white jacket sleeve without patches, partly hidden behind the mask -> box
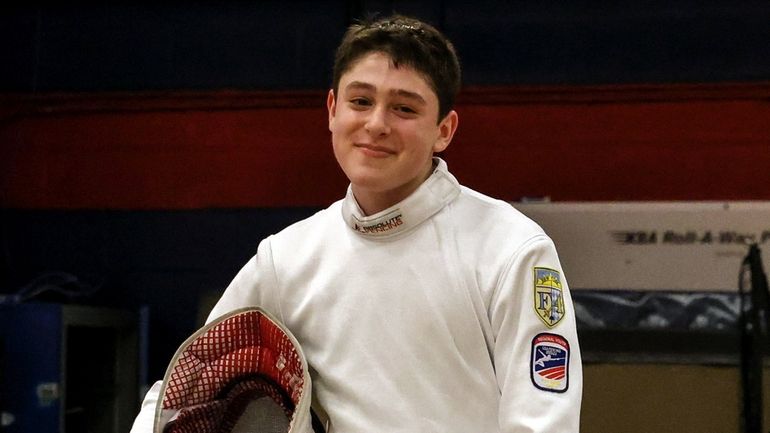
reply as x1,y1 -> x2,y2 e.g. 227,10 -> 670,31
130,238 -> 283,433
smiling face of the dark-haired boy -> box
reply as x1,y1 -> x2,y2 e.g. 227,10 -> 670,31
327,52 -> 457,215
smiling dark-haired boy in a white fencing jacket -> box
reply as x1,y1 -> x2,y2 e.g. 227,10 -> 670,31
135,16 -> 582,433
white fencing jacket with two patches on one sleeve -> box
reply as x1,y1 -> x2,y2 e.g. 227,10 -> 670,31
133,159 -> 582,433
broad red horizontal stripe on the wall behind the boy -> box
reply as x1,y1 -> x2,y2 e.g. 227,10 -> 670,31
0,83 -> 770,209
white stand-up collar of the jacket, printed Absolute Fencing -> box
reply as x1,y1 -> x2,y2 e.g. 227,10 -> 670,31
342,158 -> 460,239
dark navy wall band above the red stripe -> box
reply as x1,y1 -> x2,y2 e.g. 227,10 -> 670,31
0,0 -> 770,92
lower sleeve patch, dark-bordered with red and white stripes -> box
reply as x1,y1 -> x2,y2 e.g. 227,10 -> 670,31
530,333 -> 569,392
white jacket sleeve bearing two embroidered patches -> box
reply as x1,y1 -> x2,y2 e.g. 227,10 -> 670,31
489,235 -> 583,433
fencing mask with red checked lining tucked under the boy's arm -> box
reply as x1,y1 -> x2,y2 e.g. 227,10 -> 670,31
153,308 -> 313,433
